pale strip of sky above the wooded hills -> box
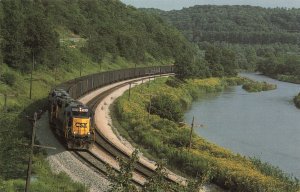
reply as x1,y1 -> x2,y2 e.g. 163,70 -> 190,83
121,0 -> 300,11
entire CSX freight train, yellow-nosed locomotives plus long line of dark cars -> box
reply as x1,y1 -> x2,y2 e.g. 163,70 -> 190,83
48,65 -> 174,149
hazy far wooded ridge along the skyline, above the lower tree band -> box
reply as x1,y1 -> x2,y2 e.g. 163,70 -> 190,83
155,5 -> 300,44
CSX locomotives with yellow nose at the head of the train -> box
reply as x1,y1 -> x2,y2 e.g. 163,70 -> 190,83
48,89 -> 95,149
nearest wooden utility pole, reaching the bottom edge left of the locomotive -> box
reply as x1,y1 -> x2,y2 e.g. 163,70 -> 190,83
25,112 -> 56,192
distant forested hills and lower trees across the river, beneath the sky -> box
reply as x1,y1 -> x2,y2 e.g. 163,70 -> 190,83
143,5 -> 300,80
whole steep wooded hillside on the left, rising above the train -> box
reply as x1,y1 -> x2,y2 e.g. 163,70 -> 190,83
0,0 -> 195,72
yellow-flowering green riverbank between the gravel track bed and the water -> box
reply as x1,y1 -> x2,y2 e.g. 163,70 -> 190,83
116,78 -> 299,191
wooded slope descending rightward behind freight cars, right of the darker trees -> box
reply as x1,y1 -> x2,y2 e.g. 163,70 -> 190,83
44,0 -> 192,63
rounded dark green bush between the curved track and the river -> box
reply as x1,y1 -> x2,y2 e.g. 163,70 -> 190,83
148,94 -> 183,122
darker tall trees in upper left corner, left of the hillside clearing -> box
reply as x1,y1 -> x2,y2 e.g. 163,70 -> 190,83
1,0 -> 59,71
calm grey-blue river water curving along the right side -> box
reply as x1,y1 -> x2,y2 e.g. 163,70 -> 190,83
185,73 -> 300,178
